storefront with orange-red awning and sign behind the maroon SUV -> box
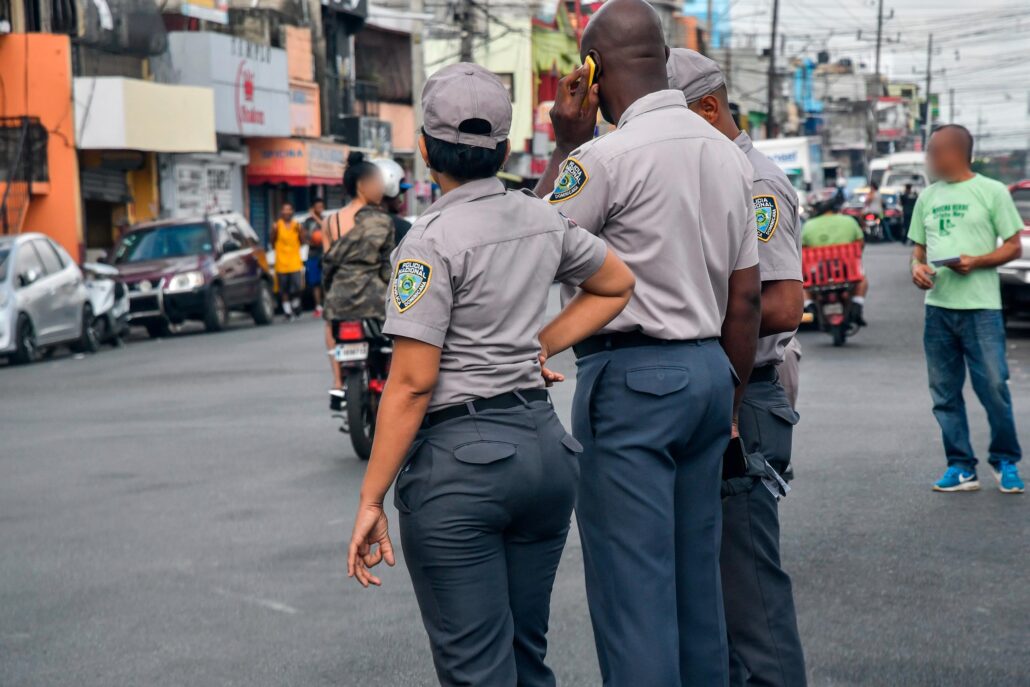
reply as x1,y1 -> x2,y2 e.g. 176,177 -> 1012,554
247,138 -> 348,246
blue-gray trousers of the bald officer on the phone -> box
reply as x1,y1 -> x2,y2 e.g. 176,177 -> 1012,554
573,341 -> 733,687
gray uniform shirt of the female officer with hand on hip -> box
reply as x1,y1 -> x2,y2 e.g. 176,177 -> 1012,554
383,178 -> 608,410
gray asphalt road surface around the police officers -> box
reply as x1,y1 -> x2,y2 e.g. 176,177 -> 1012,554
0,247 -> 1030,687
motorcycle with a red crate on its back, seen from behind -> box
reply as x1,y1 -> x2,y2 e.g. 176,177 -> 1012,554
801,242 -> 863,346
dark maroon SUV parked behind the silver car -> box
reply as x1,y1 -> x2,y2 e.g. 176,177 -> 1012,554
108,212 -> 275,337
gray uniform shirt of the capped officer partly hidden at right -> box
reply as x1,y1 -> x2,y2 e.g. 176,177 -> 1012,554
733,131 -> 802,368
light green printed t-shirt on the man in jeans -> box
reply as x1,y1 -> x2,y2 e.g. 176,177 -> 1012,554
908,174 -> 1023,310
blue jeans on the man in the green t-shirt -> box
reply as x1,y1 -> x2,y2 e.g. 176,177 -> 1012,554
923,305 -> 1022,470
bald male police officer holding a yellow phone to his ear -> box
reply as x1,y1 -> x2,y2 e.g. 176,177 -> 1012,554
538,0 -> 760,687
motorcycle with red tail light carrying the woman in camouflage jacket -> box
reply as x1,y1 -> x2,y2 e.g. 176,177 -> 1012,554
331,319 -> 393,460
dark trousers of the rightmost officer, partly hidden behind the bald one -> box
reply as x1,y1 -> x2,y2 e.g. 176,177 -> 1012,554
721,381 -> 805,687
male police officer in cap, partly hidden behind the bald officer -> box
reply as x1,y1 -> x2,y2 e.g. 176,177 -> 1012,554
668,48 -> 804,687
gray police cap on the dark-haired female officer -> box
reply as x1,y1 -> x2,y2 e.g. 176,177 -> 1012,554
422,62 -> 512,150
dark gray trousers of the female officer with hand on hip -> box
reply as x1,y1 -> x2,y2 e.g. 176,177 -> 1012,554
394,402 -> 582,687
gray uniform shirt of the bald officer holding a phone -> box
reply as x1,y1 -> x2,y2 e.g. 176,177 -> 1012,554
550,90 -> 758,340
